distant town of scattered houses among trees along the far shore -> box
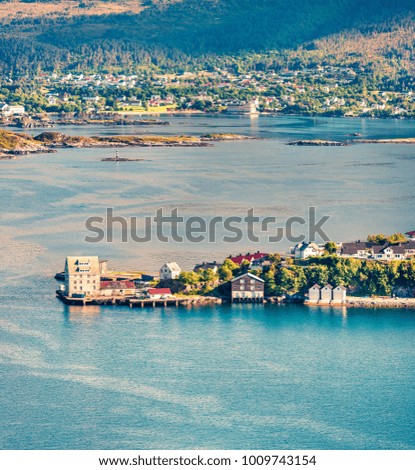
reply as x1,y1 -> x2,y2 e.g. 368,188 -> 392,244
0,65 -> 415,127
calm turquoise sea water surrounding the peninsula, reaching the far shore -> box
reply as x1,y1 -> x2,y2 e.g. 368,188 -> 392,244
0,116 -> 415,449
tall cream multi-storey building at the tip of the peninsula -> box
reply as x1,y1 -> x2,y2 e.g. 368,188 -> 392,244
65,256 -> 101,297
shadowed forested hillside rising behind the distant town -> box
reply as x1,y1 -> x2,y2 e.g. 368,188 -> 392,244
0,0 -> 415,72
